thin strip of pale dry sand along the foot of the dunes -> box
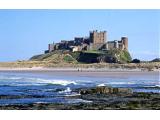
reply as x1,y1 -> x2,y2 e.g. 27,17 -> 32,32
0,67 -> 160,72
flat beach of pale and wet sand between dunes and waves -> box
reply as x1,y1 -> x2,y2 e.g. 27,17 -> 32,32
0,67 -> 160,79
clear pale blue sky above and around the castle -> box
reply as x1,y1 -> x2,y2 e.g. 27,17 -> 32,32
0,9 -> 160,62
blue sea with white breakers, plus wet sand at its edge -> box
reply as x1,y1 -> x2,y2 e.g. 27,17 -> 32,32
0,71 -> 160,105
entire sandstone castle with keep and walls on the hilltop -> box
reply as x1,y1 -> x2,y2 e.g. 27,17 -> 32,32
45,30 -> 128,53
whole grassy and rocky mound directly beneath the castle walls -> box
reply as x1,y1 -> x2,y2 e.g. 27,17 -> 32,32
30,49 -> 132,63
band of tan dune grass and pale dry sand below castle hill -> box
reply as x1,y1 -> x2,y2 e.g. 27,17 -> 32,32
0,61 -> 160,72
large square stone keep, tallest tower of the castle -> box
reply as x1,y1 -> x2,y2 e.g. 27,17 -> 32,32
90,30 -> 107,44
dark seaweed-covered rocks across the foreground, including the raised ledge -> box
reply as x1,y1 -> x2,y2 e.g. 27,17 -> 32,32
0,86 -> 160,110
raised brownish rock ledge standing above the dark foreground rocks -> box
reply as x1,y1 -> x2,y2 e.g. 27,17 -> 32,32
79,86 -> 133,95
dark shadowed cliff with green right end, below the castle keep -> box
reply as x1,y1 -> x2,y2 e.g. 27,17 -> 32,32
77,50 -> 132,63
